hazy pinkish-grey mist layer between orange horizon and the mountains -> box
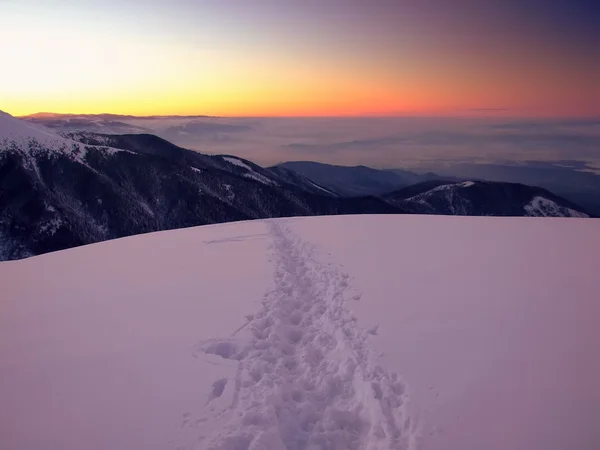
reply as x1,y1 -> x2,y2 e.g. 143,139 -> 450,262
132,117 -> 600,168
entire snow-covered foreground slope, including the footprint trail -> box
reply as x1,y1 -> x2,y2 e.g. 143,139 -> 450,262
0,216 -> 600,450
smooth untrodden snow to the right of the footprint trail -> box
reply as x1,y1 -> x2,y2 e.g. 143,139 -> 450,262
290,216 -> 600,450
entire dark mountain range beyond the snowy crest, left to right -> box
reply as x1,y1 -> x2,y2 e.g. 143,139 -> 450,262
0,113 -> 587,260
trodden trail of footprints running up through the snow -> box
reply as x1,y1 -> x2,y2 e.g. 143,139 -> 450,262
179,221 -> 416,450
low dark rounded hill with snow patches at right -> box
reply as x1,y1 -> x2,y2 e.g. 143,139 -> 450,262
383,180 -> 589,217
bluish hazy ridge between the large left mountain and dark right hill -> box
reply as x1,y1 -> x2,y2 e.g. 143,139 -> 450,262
271,161 -> 454,197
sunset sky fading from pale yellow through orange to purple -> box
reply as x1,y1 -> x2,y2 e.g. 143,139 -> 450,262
0,0 -> 600,117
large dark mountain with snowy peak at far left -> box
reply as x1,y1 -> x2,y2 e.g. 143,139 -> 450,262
0,113 -> 403,260
